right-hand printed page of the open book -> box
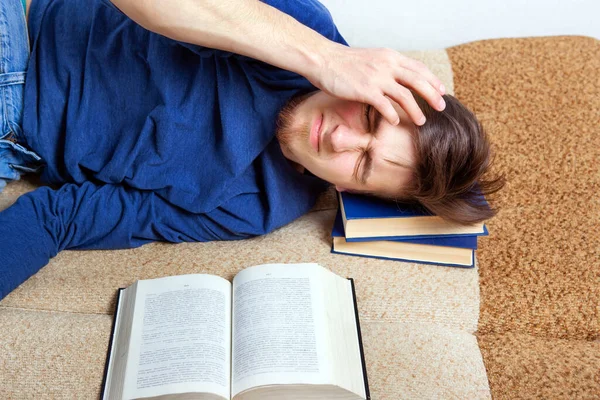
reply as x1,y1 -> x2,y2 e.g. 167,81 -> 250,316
232,264 -> 332,396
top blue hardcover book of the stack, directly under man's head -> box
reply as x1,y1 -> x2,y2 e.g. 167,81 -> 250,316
339,192 -> 487,241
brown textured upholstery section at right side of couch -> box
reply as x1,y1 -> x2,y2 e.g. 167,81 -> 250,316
448,36 -> 600,399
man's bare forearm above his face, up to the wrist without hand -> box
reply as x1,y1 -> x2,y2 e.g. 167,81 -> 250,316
111,0 -> 333,76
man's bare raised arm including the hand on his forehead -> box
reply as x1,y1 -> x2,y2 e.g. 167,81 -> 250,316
111,0 -> 446,125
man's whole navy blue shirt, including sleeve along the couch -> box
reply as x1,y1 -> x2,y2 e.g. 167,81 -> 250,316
0,0 -> 347,299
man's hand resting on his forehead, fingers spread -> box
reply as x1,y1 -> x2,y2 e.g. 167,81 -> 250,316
306,42 -> 446,125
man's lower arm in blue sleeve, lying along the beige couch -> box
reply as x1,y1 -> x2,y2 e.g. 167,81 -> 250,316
0,181 -> 265,300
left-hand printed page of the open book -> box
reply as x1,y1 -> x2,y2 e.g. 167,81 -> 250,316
123,274 -> 231,399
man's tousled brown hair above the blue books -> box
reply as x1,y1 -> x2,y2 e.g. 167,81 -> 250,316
398,93 -> 505,225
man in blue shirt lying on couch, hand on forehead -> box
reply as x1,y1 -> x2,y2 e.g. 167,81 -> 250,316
0,0 -> 502,298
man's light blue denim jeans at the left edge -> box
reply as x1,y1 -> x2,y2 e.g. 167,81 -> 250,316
0,0 -> 43,192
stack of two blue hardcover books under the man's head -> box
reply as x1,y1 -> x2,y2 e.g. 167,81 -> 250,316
331,192 -> 488,268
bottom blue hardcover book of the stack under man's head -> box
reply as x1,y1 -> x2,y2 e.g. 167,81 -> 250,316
331,210 -> 477,268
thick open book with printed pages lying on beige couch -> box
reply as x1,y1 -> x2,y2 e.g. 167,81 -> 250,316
102,264 -> 369,400
